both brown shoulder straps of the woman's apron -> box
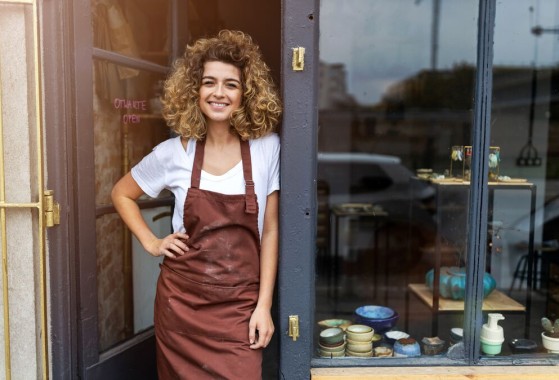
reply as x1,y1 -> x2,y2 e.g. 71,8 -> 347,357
190,140 -> 257,214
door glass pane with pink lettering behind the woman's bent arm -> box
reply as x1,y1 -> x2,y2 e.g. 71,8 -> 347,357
93,60 -> 172,351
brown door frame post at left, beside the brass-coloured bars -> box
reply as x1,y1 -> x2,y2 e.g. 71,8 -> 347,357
43,0 -> 78,380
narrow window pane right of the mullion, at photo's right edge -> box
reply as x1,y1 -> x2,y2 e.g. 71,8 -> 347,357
492,0 -> 559,355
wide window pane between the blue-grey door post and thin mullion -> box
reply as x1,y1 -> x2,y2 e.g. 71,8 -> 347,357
314,0 -> 480,365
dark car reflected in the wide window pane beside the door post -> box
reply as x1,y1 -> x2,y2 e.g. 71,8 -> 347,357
317,152 -> 436,276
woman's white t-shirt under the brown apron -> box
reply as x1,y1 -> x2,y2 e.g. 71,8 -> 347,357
131,133 -> 280,238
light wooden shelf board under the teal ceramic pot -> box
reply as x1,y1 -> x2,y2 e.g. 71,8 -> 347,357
408,284 -> 526,312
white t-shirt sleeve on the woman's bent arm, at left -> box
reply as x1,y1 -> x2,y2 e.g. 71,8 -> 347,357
130,146 -> 166,198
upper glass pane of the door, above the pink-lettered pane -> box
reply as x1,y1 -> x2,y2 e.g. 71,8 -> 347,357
91,0 -> 170,65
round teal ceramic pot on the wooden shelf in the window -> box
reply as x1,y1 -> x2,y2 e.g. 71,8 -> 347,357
425,267 -> 497,300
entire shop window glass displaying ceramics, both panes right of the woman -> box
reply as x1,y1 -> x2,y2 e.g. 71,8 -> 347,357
313,0 -> 559,365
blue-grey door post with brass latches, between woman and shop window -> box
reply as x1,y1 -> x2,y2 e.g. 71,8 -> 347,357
277,0 -> 319,379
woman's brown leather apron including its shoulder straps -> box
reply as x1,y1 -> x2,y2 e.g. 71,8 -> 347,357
155,141 -> 262,380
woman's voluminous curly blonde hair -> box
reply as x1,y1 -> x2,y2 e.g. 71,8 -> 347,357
162,30 -> 282,140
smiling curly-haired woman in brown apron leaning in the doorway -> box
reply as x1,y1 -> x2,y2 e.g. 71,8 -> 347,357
112,31 -> 281,379
